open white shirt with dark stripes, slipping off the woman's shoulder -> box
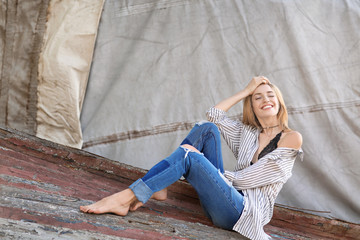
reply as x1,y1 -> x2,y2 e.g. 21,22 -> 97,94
207,108 -> 302,240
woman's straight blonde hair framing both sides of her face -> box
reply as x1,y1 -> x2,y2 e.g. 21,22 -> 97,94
242,83 -> 290,130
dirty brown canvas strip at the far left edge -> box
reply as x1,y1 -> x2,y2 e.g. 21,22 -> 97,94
0,0 -> 48,134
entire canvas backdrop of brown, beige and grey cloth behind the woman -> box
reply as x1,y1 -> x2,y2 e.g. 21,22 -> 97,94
0,0 -> 360,223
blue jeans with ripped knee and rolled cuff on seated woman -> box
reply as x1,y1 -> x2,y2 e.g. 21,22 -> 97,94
129,122 -> 244,230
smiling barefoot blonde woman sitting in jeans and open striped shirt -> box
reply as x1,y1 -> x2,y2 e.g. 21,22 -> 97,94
80,76 -> 302,239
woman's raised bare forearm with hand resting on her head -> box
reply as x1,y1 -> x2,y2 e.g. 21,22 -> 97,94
214,76 -> 269,112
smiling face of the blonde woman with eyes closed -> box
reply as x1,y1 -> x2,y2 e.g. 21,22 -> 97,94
251,84 -> 279,119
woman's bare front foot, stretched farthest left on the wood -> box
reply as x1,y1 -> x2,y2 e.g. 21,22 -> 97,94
80,188 -> 137,216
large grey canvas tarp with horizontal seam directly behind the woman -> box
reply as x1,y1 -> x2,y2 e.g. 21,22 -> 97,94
81,0 -> 360,223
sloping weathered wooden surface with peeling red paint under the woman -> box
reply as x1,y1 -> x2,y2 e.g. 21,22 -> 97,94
0,126 -> 360,239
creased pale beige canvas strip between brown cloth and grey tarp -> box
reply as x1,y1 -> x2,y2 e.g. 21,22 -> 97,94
36,0 -> 103,148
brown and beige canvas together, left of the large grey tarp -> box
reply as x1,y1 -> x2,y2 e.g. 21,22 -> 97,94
0,0 -> 104,148
